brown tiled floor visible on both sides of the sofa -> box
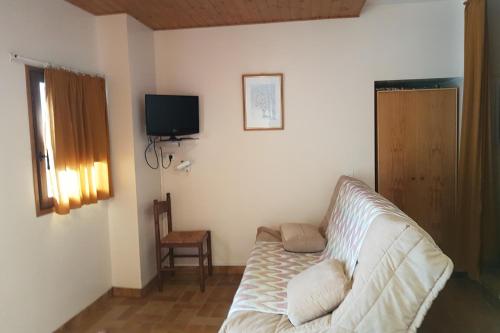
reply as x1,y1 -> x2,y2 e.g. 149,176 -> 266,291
61,273 -> 500,333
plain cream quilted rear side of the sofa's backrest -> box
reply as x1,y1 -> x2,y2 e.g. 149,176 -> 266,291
331,202 -> 453,332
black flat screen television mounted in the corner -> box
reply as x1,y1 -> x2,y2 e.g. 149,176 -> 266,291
146,95 -> 200,138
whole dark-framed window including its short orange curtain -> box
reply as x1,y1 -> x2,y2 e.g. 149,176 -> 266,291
26,66 -> 112,216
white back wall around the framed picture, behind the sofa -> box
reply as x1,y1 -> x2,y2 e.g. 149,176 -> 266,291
155,0 -> 463,265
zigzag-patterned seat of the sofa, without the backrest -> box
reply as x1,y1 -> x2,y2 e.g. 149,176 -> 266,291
229,242 -> 321,316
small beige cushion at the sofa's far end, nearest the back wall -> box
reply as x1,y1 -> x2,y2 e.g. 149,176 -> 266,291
281,223 -> 326,252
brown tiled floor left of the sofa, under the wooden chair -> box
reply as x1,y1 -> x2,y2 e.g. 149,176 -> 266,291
62,273 -> 241,333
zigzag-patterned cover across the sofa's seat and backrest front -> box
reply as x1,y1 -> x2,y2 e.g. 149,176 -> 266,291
229,176 -> 416,316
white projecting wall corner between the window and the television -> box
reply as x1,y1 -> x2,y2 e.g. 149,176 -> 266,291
97,14 -> 160,288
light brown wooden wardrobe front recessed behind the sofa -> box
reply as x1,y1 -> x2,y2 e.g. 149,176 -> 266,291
377,88 -> 457,257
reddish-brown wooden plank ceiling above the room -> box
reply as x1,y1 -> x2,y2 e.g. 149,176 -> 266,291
66,0 -> 366,30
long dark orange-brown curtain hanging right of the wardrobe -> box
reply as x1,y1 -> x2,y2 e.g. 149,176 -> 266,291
455,0 -> 495,279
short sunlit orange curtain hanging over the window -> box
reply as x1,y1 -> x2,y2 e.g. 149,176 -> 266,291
45,68 -> 112,214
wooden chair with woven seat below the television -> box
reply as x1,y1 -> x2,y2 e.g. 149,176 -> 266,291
153,193 -> 213,292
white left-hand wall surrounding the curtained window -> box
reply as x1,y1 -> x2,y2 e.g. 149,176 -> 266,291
0,0 -> 111,333
